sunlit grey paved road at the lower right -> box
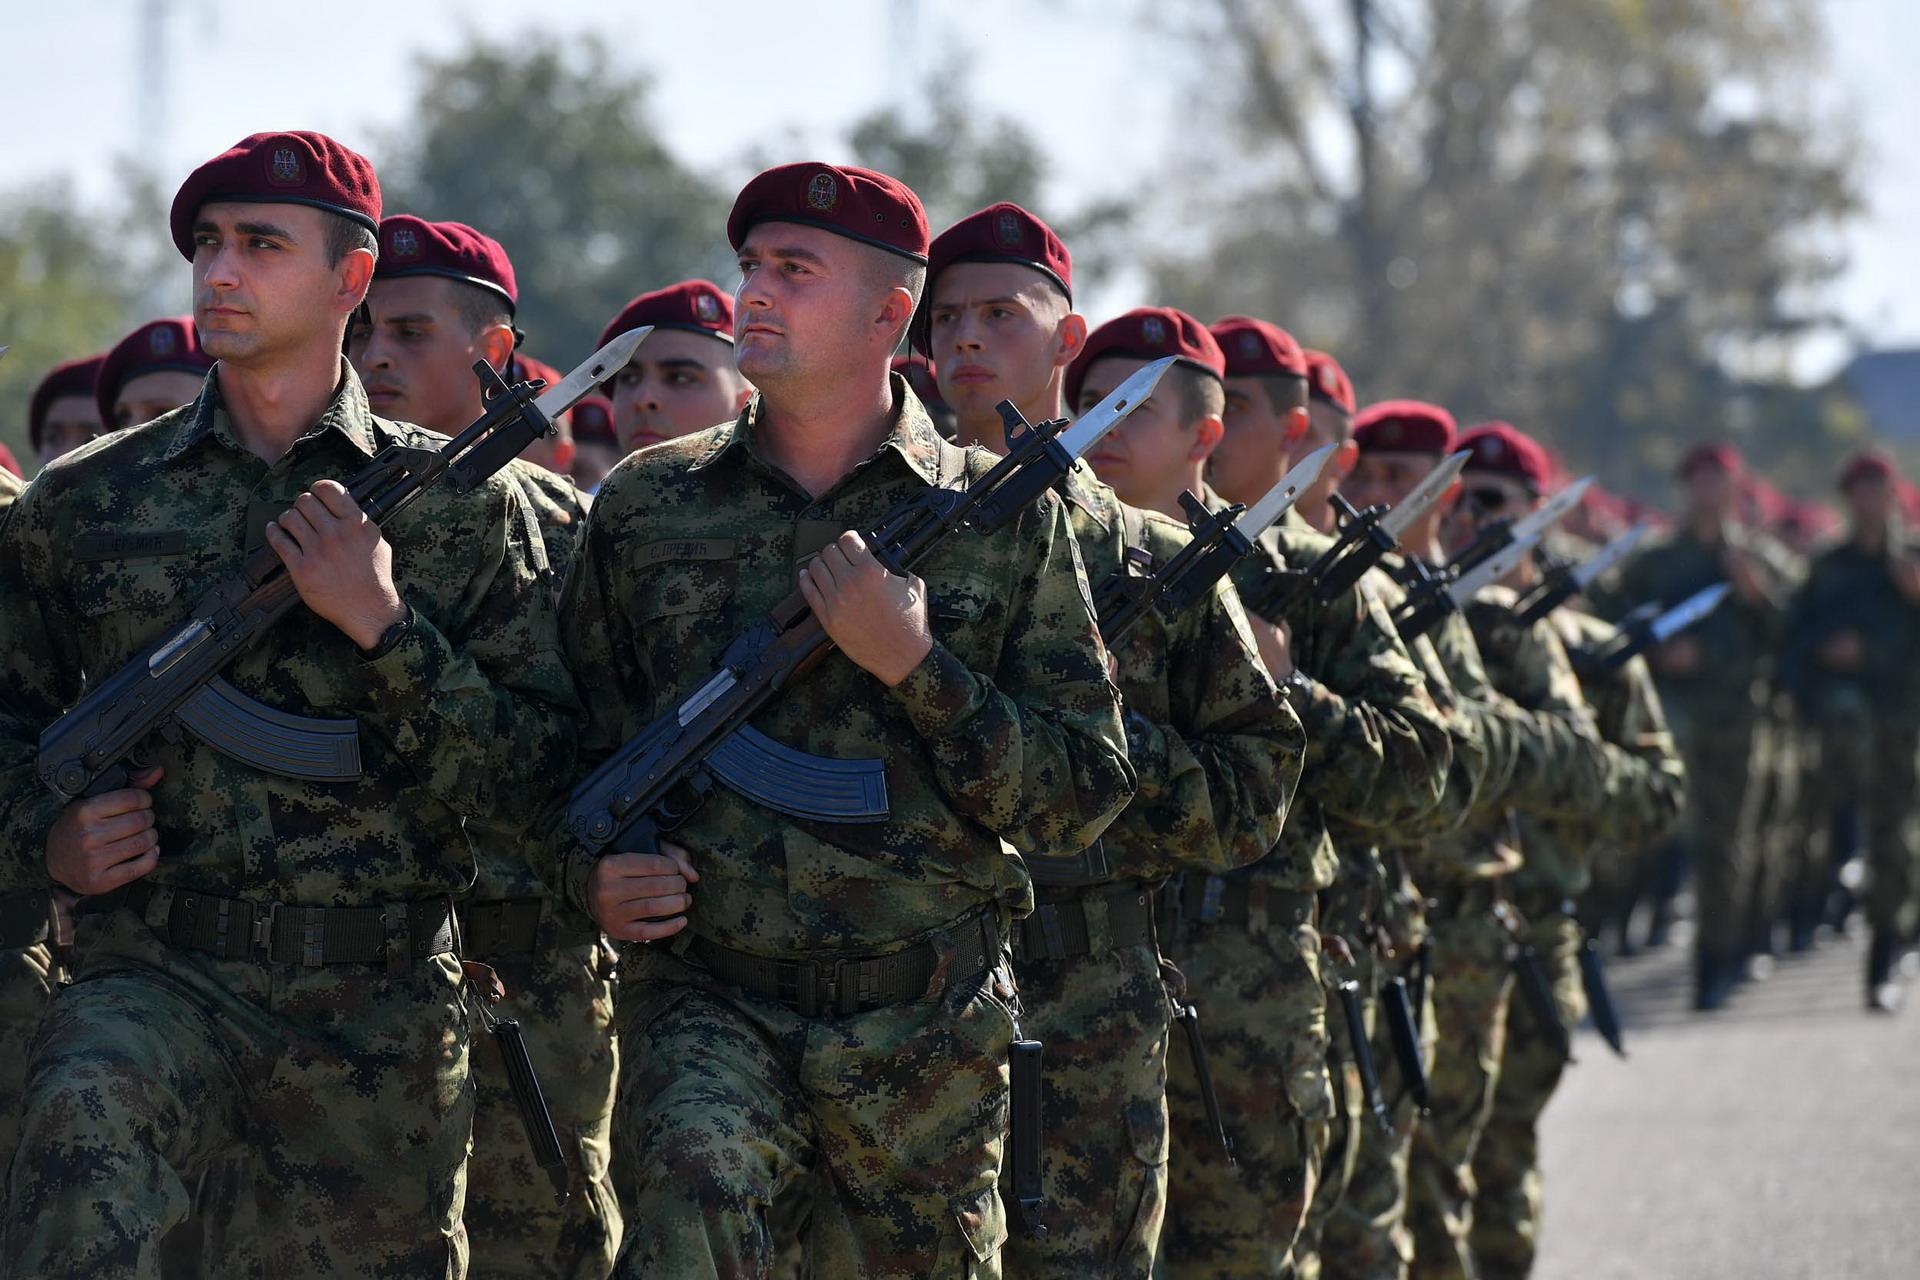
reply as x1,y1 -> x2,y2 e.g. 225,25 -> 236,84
1534,940 -> 1920,1280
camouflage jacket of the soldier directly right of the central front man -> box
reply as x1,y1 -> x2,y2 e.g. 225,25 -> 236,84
1043,464 -> 1306,883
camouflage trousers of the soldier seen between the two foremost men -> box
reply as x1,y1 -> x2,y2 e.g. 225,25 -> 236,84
467,919 -> 620,1280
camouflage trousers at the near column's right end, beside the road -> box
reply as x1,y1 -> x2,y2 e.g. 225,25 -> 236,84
1473,912 -> 1586,1280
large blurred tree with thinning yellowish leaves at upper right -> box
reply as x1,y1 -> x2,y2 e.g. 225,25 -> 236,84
1154,0 -> 1857,506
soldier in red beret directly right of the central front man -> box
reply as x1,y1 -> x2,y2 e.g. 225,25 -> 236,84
922,203 -> 1304,1280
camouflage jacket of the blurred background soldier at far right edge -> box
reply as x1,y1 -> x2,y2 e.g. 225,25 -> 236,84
1774,533 -> 1920,723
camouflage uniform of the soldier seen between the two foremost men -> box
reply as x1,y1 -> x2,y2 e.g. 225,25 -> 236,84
459,461 -> 620,1280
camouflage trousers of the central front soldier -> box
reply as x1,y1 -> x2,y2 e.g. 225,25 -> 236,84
614,932 -> 1014,1280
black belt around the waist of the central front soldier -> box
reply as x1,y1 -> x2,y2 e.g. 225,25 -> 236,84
687,912 -> 1000,1017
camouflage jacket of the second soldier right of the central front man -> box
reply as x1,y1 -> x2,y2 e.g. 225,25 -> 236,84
1208,506 -> 1452,890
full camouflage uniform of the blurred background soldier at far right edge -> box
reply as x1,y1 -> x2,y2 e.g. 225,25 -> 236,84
1780,526 -> 1920,984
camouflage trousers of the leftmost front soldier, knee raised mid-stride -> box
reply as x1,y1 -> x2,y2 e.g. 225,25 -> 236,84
4,912 -> 472,1280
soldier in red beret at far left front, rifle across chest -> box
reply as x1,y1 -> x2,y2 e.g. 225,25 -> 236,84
0,132 -> 576,1276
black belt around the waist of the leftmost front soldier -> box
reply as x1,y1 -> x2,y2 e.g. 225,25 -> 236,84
107,881 -> 455,973
